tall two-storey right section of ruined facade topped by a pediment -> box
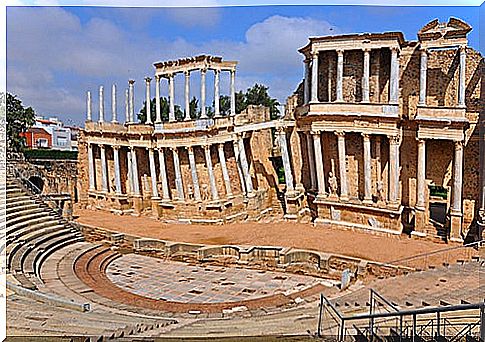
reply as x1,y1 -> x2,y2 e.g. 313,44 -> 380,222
289,18 -> 484,241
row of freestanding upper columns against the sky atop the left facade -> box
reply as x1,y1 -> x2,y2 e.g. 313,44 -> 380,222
86,69 -> 236,124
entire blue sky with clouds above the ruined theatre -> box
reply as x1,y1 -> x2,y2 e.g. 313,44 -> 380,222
7,5 -> 485,124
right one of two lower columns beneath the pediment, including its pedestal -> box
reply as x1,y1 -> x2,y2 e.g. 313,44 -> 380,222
450,141 -> 463,241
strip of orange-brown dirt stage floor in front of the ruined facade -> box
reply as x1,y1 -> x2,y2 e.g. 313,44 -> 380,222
75,209 -> 466,262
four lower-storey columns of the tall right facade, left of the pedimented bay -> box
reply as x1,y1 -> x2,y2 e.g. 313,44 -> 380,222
306,131 -> 400,204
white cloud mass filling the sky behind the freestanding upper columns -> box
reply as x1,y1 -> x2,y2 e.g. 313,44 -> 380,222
7,7 -> 338,123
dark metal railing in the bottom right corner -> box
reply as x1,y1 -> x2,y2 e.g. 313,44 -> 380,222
316,290 -> 485,341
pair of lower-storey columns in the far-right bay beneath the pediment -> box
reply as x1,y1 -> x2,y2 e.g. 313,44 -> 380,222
416,139 -> 463,215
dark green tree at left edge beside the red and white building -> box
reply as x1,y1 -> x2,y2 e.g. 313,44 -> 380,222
7,93 -> 35,152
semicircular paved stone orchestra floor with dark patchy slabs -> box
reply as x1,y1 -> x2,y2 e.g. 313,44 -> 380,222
106,254 -> 332,303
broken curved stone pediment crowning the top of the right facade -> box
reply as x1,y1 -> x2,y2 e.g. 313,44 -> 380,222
418,18 -> 472,47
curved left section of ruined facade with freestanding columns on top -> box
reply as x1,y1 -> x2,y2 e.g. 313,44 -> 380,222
79,56 -> 293,223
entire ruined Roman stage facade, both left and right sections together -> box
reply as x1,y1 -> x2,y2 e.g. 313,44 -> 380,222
79,18 -> 485,241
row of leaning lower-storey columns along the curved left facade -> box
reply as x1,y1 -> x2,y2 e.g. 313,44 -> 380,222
88,136 -> 254,201
